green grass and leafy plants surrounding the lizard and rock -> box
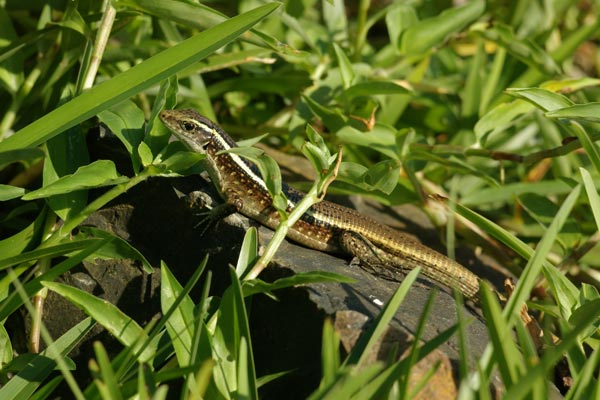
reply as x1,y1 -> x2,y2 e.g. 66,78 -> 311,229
0,0 -> 600,399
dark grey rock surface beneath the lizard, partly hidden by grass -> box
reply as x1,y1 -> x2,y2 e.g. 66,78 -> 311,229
12,171 -> 506,398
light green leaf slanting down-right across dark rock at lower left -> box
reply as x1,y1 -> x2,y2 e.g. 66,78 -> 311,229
42,282 -> 157,362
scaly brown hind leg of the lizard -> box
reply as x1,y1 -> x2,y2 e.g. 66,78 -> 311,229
340,231 -> 406,282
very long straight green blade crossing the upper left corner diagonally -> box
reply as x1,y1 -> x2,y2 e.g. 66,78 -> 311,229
0,3 -> 279,152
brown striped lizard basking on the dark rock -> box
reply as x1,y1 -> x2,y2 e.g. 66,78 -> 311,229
159,109 -> 480,300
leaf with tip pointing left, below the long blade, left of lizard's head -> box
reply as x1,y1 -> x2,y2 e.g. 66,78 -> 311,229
23,160 -> 128,200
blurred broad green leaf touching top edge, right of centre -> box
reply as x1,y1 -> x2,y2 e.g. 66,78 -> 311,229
400,0 -> 485,55
